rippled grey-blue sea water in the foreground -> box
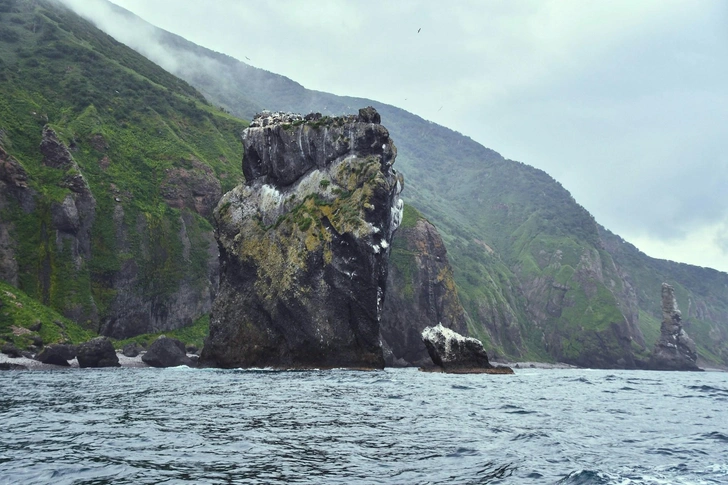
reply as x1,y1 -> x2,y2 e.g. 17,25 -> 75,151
0,368 -> 728,485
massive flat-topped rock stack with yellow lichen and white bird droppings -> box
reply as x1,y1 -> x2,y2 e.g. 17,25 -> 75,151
200,108 -> 402,368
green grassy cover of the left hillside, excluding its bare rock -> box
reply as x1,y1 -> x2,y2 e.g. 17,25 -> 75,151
0,0 -> 246,348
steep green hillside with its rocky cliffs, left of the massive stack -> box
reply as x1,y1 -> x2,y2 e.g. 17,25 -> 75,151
0,0 -> 246,337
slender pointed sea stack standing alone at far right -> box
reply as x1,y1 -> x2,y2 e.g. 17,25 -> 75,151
649,283 -> 701,370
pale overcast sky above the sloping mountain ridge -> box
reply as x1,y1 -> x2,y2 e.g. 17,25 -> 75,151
65,0 -> 728,271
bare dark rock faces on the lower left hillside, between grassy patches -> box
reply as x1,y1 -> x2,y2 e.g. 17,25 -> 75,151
0,126 -> 221,338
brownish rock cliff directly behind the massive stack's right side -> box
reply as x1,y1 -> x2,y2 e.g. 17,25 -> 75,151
381,206 -> 467,367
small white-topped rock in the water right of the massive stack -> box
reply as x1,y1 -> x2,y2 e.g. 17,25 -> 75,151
422,324 -> 513,374
